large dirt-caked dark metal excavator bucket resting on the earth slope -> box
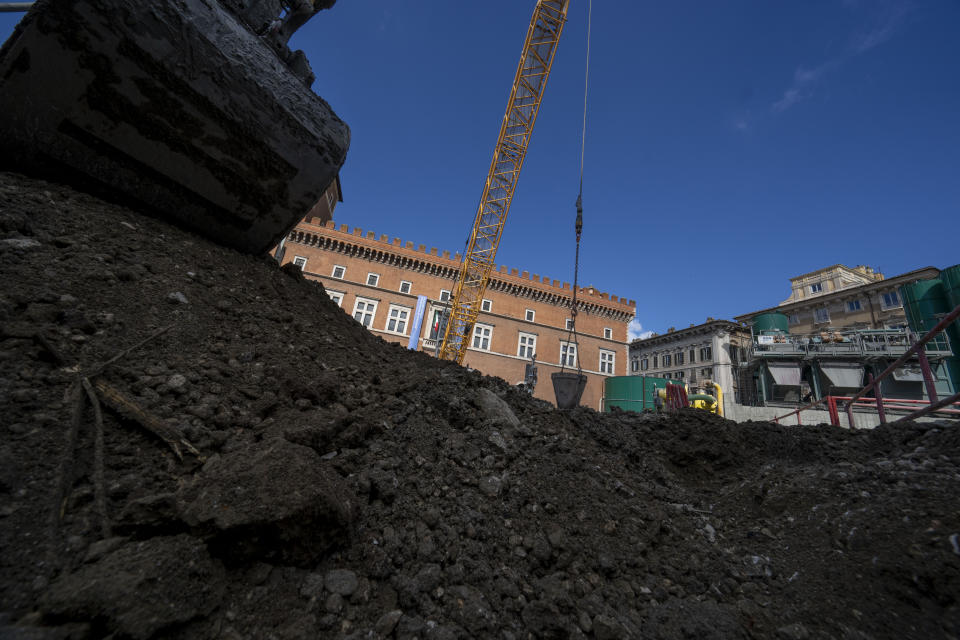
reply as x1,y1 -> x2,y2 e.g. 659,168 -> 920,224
0,0 -> 350,253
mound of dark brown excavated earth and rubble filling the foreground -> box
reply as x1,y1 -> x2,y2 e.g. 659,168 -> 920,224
0,174 -> 960,640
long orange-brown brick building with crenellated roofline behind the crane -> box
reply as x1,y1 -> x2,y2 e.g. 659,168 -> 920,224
279,220 -> 636,409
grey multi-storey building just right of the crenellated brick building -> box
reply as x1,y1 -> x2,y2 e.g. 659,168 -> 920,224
629,318 -> 750,411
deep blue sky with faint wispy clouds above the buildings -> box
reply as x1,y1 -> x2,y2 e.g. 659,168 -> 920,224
0,0 -> 960,340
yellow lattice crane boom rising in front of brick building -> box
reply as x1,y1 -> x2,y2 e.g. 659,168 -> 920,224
438,0 -> 570,364
